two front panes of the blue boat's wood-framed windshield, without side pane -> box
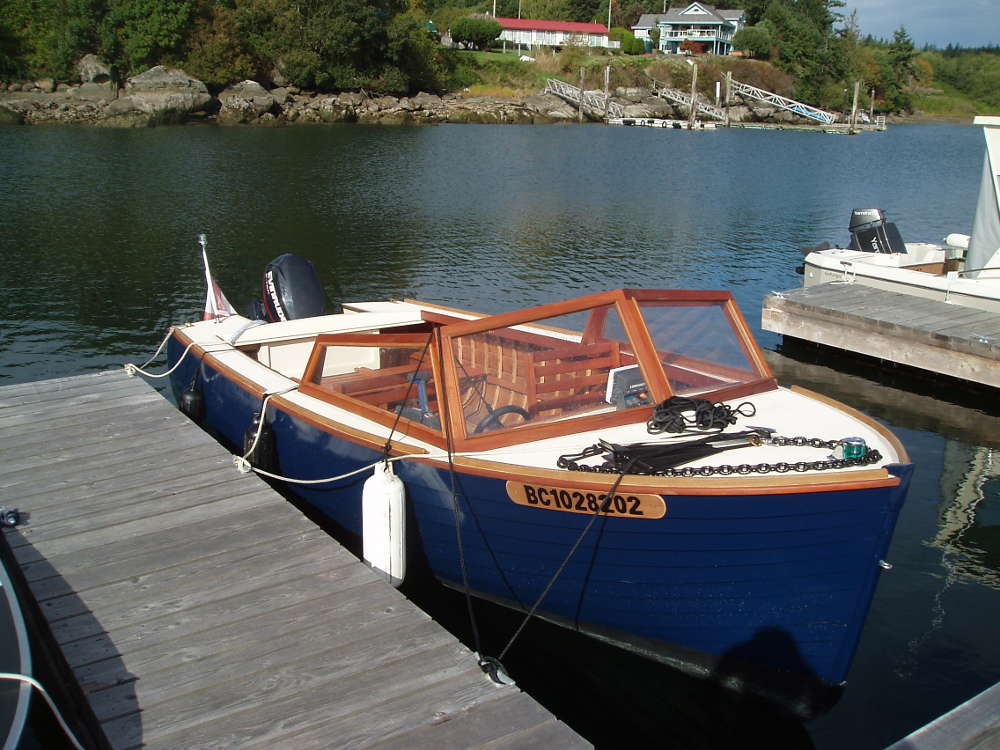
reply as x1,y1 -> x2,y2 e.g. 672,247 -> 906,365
442,290 -> 773,439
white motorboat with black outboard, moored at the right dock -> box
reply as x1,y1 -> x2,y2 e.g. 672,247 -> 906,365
802,117 -> 1000,312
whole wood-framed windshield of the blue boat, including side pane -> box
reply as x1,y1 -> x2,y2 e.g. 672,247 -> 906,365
300,290 -> 775,450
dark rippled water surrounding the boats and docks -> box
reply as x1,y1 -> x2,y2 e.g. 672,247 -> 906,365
0,120 -> 1000,750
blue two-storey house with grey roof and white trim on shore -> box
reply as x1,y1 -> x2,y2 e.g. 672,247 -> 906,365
632,2 -> 746,55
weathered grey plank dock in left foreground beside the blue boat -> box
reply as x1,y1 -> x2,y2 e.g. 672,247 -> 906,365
0,372 -> 588,750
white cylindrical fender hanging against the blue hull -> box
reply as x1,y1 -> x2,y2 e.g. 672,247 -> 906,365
361,461 -> 406,587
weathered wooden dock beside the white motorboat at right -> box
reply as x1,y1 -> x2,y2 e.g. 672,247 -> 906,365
761,282 -> 1000,388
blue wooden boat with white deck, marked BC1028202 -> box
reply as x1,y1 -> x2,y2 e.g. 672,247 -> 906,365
162,283 -> 912,714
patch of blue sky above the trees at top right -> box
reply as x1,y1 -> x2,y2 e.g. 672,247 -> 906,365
840,0 -> 1000,48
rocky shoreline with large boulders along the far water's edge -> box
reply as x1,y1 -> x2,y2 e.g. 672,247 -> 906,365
0,61 -> 844,128
